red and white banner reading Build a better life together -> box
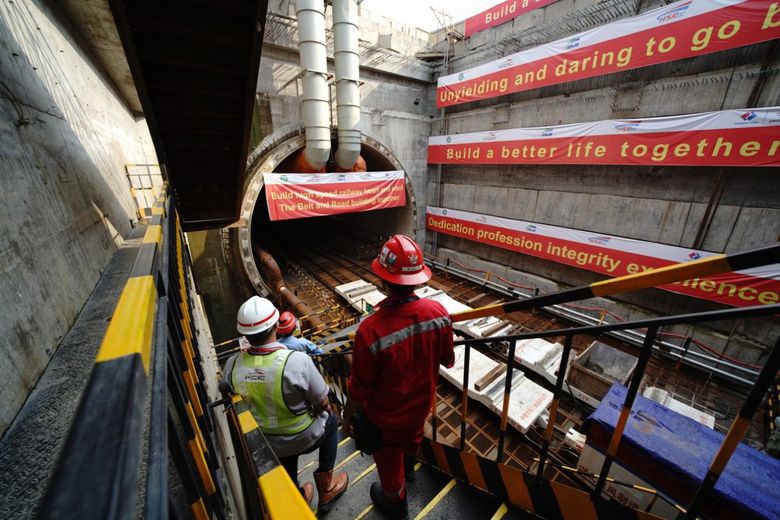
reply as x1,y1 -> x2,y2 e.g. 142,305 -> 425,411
428,107 -> 780,166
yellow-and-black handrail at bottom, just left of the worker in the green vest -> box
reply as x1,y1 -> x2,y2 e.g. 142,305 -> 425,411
223,394 -> 315,520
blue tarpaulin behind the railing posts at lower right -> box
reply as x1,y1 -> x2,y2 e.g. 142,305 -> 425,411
584,384 -> 780,519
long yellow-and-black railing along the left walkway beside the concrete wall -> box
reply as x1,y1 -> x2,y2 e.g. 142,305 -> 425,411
39,196 -> 226,520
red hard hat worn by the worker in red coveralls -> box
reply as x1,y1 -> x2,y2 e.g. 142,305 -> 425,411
371,235 -> 432,285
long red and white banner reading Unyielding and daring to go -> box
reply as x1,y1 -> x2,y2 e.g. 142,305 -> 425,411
436,0 -> 780,108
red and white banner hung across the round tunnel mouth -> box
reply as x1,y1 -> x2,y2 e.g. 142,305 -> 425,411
263,171 -> 406,220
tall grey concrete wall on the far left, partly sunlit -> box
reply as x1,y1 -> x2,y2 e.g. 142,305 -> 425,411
0,1 -> 157,434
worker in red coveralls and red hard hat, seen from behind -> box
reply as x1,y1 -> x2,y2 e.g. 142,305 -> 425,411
344,235 -> 455,518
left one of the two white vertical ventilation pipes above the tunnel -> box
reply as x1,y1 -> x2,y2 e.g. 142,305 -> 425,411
297,0 -> 330,170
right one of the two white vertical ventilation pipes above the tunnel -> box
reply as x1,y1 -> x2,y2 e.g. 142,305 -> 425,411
333,0 -> 360,170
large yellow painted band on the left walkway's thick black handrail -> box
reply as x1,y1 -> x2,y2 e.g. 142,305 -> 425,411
95,275 -> 157,374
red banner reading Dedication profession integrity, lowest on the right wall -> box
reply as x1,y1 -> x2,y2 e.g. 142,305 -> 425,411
425,207 -> 780,307
